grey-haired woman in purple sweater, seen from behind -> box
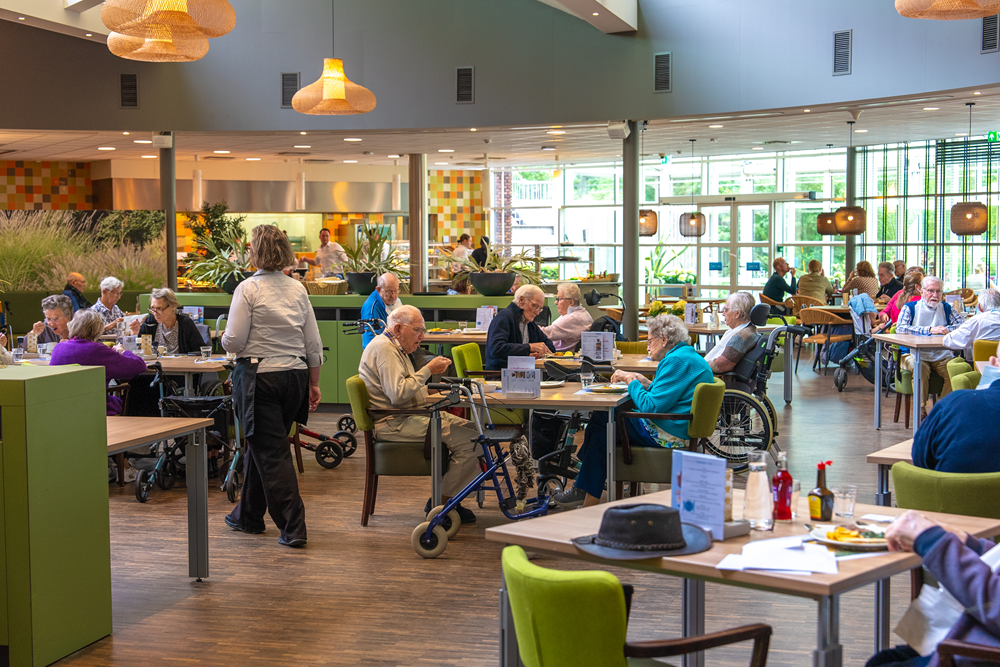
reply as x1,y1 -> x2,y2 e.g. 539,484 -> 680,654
49,310 -> 146,417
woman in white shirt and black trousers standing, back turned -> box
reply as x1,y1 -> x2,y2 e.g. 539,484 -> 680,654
222,225 -> 323,547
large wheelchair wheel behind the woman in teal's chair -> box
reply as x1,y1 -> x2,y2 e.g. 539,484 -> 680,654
703,391 -> 774,472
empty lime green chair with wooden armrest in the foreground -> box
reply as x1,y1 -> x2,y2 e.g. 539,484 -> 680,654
501,546 -> 771,667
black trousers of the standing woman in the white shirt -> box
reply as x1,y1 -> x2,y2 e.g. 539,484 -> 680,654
230,370 -> 309,540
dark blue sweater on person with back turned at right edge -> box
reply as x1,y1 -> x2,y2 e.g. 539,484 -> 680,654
911,380 -> 1000,472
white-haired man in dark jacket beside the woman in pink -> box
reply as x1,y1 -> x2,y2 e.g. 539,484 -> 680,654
484,285 -> 556,371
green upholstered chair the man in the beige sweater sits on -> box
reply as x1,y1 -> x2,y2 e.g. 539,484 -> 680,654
347,375 -> 431,526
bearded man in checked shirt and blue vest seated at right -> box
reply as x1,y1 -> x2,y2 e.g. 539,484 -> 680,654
896,276 -> 962,409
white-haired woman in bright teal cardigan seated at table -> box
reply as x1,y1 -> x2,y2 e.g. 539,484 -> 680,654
553,315 -> 715,507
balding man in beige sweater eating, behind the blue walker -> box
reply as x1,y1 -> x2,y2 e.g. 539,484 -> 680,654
358,306 -> 479,523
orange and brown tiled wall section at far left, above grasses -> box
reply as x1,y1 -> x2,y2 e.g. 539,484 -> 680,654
0,161 -> 94,211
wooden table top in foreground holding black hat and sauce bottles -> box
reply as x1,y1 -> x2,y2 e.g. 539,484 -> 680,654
486,489 -> 1000,599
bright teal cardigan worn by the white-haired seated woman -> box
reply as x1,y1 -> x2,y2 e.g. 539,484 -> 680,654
628,343 -> 715,440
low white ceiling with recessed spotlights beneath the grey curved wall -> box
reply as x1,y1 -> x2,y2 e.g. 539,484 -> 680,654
0,86 -> 1000,168
